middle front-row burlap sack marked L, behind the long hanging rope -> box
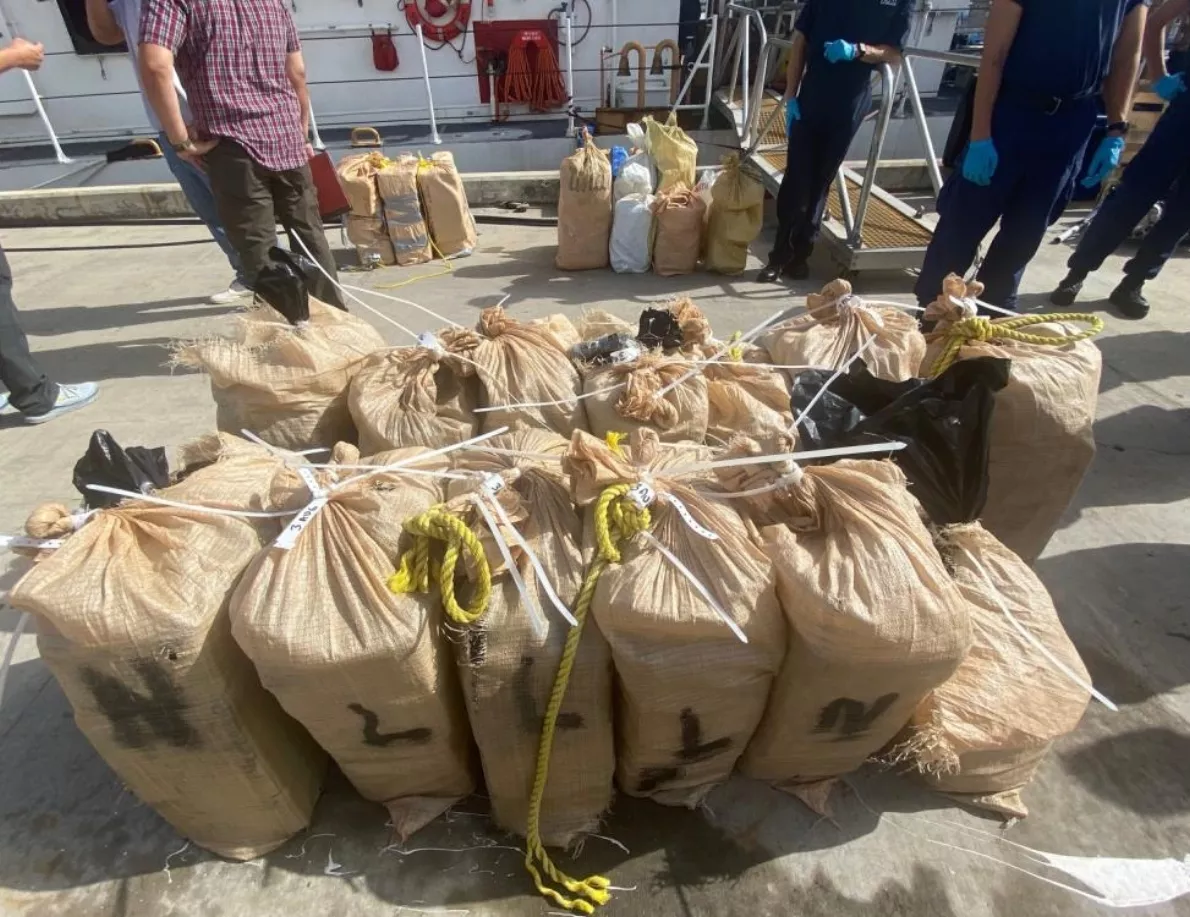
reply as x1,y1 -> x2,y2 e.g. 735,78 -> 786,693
442,429 -> 615,847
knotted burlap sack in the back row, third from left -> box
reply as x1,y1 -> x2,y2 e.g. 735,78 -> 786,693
475,306 -> 587,438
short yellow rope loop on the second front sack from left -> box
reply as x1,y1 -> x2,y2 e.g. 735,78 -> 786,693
388,507 -> 491,627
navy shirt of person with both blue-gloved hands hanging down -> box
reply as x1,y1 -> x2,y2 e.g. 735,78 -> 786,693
1001,0 -> 1150,99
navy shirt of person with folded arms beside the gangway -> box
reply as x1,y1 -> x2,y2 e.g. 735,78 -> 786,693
794,0 -> 913,121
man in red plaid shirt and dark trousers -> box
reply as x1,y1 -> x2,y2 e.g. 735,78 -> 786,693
139,0 -> 343,308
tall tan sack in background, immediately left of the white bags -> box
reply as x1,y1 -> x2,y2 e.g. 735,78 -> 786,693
557,131 -> 612,271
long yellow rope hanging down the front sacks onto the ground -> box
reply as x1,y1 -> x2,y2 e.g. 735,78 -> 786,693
525,484 -> 652,915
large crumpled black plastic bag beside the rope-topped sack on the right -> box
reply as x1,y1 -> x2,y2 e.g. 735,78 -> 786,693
793,357 -> 1010,526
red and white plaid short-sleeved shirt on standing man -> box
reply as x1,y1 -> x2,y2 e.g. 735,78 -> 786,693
140,0 -> 307,171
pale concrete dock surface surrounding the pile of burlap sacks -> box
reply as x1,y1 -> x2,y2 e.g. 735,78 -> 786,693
0,216 -> 1190,917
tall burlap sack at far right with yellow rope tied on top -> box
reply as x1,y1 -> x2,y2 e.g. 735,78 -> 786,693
922,277 -> 1103,564
